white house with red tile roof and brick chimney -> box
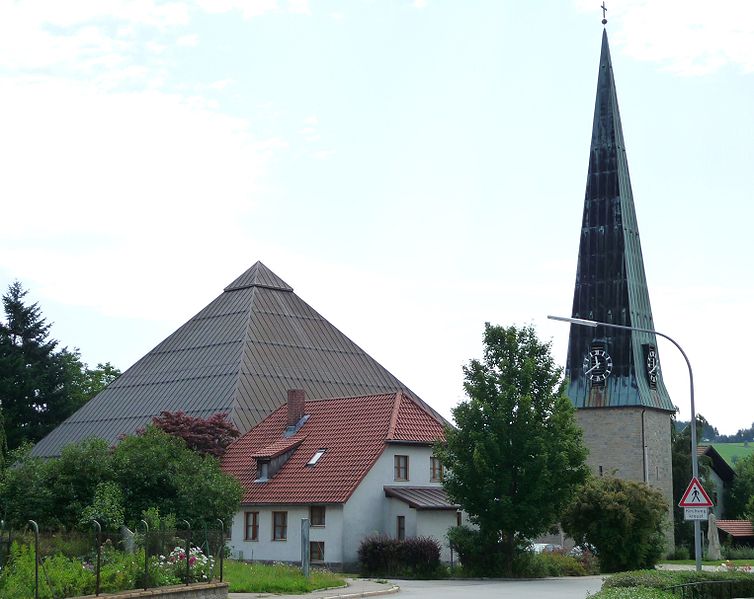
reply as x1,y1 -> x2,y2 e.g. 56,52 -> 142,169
222,390 -> 464,566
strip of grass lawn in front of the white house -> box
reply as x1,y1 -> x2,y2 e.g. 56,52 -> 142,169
223,560 -> 346,594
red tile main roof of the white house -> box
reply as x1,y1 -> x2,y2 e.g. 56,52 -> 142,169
222,392 -> 445,504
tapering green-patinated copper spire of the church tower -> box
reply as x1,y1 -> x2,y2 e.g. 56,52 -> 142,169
566,31 -> 675,411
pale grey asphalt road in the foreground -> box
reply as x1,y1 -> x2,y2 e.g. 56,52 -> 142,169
388,576 -> 602,599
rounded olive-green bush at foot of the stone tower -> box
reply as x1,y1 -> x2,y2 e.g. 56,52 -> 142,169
561,476 -> 668,572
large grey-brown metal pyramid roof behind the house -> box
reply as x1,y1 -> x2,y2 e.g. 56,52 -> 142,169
34,262 -> 434,456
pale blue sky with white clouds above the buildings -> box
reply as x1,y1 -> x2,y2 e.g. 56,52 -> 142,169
0,0 -> 754,434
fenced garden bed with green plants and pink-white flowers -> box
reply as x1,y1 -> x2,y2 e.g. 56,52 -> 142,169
0,520 -> 226,599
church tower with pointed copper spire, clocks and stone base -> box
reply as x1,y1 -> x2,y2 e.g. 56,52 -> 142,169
566,21 -> 675,542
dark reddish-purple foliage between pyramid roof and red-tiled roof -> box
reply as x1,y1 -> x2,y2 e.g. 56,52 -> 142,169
152,412 -> 241,458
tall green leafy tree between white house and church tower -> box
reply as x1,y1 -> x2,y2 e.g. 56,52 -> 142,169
436,323 -> 587,574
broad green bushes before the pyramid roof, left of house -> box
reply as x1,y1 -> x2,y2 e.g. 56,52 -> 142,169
0,427 -> 241,529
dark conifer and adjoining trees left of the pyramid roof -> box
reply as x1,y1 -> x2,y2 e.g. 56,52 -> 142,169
0,281 -> 120,454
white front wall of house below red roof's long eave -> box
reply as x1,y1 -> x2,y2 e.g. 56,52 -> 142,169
229,505 -> 343,564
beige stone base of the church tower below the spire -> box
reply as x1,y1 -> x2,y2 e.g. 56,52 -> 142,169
576,407 -> 675,552
